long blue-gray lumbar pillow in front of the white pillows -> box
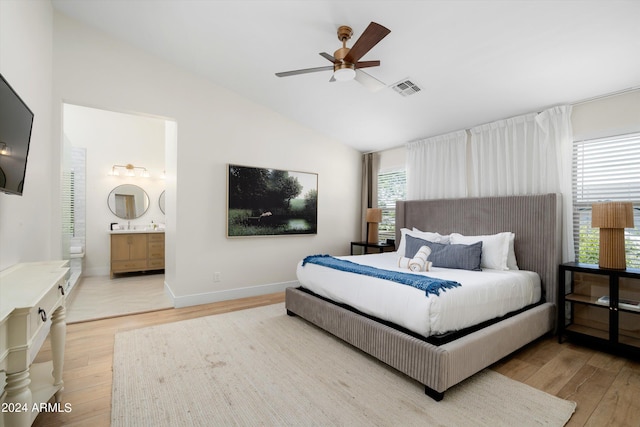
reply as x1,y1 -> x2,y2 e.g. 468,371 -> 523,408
405,236 -> 482,271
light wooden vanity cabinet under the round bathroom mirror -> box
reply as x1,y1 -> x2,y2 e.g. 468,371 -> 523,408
111,233 -> 164,278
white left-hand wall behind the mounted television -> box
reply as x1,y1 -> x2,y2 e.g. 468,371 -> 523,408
0,0 -> 55,270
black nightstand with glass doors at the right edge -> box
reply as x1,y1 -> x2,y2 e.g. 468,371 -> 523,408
558,262 -> 640,357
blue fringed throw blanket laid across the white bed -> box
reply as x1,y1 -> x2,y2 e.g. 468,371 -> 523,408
302,255 -> 460,296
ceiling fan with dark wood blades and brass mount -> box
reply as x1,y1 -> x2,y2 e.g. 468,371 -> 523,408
276,22 -> 391,91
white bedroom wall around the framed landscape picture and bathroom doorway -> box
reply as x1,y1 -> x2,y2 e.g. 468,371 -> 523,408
54,13 -> 361,305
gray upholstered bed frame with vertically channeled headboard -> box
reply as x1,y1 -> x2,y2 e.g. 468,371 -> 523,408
285,194 -> 561,401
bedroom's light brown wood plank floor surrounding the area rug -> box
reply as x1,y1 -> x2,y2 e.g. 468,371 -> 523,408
34,293 -> 640,427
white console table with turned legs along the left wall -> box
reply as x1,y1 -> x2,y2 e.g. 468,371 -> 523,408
0,261 -> 69,427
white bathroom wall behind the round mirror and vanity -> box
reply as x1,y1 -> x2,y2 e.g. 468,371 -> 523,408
63,104 -> 165,276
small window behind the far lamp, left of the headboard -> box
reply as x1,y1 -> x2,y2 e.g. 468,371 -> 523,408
378,169 -> 407,240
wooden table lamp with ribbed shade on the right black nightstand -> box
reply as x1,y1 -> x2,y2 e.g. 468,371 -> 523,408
591,202 -> 633,270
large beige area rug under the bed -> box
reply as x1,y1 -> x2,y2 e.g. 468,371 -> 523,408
111,303 -> 575,427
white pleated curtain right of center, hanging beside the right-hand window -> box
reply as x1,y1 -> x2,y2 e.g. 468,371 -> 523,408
469,106 -> 574,261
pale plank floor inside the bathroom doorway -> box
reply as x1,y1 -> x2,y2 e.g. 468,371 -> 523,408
66,274 -> 173,323
